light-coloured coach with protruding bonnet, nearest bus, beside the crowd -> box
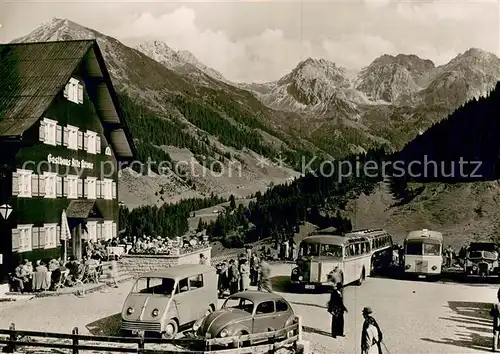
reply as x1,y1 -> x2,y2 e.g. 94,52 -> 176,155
290,232 -> 371,290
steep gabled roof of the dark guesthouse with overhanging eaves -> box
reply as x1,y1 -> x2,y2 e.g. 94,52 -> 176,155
0,40 -> 135,159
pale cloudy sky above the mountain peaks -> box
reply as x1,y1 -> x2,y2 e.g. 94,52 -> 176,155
0,0 -> 500,82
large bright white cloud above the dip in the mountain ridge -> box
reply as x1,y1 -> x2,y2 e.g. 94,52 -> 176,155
113,6 -> 312,81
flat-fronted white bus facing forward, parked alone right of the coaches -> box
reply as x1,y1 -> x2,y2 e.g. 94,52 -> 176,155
404,229 -> 443,277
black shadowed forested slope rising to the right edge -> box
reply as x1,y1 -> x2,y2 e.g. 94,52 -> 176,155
390,83 -> 500,202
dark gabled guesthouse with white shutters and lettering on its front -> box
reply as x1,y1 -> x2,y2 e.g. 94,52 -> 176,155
0,40 -> 135,276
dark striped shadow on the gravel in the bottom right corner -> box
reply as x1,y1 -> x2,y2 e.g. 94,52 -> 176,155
421,301 -> 493,351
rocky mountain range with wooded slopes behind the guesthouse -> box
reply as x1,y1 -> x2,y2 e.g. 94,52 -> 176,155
9,19 -> 500,210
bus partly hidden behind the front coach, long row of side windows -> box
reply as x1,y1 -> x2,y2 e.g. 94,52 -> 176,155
346,229 -> 394,275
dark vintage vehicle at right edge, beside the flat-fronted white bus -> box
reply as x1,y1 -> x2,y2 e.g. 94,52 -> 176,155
465,242 -> 499,277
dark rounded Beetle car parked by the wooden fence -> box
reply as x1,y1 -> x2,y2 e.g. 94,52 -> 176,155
193,291 -> 296,338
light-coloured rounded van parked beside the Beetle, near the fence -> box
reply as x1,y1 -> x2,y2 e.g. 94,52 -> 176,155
121,264 -> 217,339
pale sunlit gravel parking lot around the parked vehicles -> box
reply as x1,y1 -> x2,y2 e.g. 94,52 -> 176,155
0,264 -> 498,354
